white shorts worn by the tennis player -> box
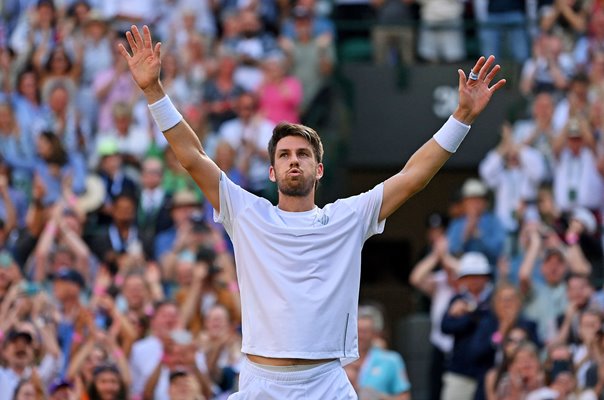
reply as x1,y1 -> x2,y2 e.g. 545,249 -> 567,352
229,358 -> 357,400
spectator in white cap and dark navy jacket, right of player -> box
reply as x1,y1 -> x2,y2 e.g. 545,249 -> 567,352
442,252 -> 493,400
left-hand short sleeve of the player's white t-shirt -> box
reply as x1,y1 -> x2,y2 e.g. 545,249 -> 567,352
214,172 -> 258,234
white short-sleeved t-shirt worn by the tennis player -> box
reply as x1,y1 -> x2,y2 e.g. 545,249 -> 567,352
214,173 -> 385,364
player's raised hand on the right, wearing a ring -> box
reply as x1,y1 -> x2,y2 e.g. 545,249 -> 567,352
453,56 -> 506,125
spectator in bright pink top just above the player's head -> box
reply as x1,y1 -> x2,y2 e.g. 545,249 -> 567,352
258,54 -> 302,123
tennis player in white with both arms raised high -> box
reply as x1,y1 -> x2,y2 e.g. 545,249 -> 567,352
120,26 -> 505,400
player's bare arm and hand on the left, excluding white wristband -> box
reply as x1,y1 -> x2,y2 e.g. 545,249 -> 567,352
119,25 -> 220,211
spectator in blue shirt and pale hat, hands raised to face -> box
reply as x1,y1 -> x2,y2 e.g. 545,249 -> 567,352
447,178 -> 505,265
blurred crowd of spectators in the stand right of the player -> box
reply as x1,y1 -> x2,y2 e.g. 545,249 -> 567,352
410,0 -> 604,400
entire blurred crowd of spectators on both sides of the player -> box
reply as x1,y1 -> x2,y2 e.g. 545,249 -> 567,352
0,0 -> 604,400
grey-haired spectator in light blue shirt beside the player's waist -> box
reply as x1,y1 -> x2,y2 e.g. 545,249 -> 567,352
345,305 -> 411,400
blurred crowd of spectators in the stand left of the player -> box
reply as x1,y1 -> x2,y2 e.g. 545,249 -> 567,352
0,0 -> 335,400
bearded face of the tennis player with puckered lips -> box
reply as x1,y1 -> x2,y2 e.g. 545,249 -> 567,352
269,136 -> 323,197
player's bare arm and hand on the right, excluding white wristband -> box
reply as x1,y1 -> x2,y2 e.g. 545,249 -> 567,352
379,56 -> 505,221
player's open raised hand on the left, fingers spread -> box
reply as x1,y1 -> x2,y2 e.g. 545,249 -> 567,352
119,25 -> 161,95
